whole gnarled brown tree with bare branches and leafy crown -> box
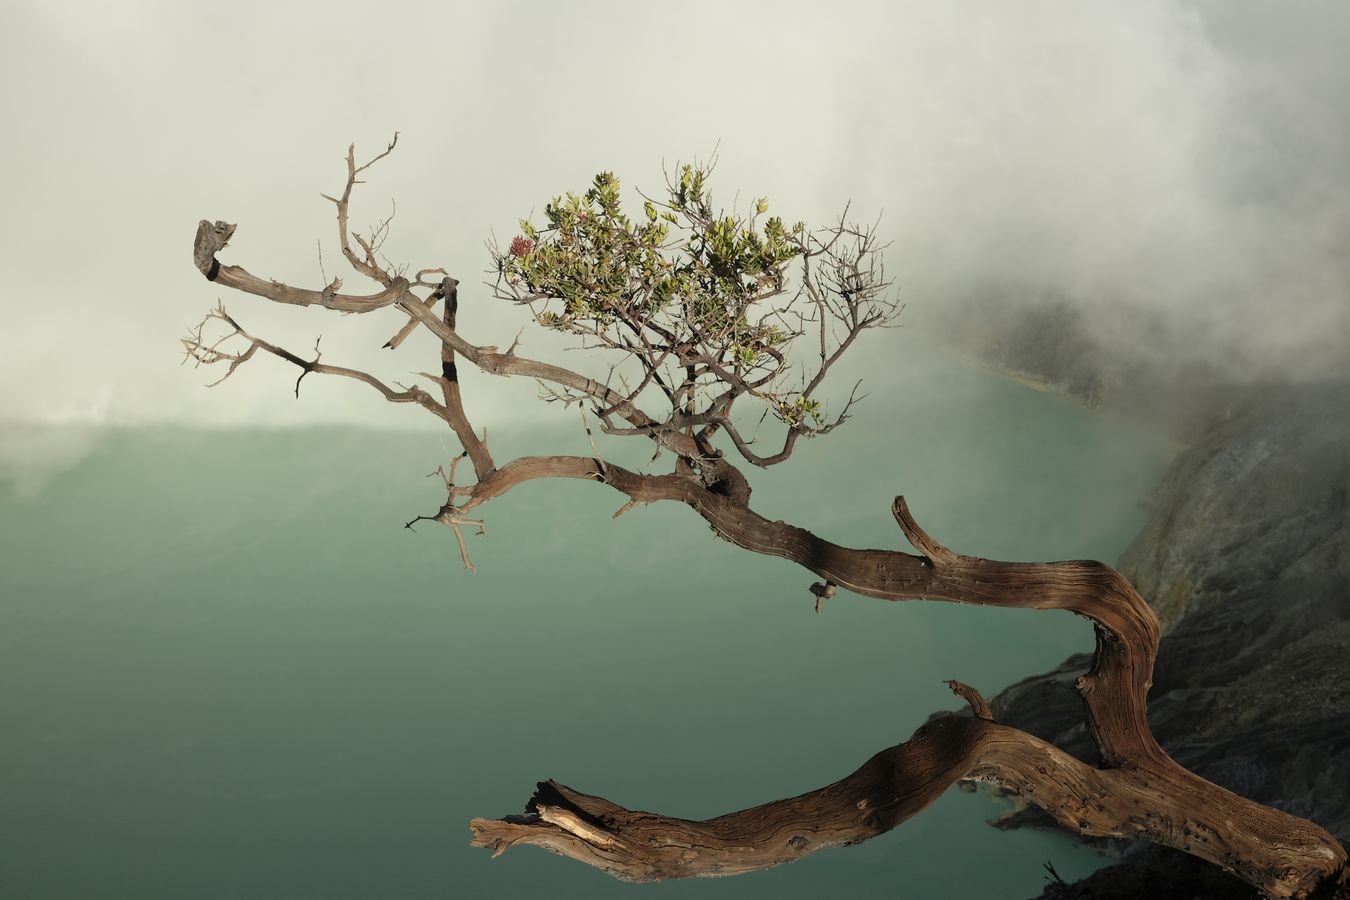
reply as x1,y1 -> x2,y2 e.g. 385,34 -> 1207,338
184,135 -> 1350,897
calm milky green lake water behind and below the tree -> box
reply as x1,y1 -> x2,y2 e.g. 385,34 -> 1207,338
0,348 -> 1169,900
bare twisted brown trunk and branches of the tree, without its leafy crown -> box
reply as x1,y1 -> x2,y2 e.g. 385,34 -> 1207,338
185,143 -> 1350,897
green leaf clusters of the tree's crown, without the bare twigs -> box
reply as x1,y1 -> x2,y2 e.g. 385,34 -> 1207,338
497,166 -> 806,370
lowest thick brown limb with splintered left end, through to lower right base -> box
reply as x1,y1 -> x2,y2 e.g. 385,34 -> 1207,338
470,685 -> 1346,897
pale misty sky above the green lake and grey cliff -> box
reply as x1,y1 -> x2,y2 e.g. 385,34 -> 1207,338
0,0 -> 1350,437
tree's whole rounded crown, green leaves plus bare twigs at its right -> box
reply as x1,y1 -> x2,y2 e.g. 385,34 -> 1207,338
494,165 -> 899,466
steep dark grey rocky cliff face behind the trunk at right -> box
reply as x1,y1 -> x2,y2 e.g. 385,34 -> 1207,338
994,382 -> 1350,897
